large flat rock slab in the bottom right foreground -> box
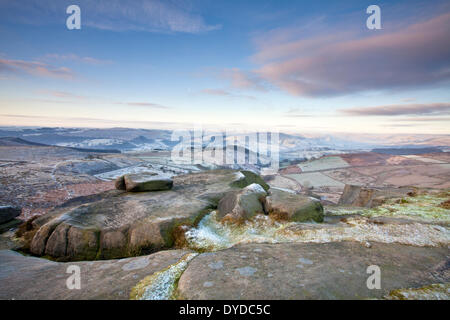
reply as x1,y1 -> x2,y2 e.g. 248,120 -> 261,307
178,242 -> 450,299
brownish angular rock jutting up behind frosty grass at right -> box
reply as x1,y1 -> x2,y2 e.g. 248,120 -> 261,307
338,184 -> 414,208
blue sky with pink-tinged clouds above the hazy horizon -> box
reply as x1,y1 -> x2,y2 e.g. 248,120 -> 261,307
0,0 -> 450,134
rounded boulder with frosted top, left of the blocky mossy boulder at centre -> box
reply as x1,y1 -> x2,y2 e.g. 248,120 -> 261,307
217,183 -> 267,222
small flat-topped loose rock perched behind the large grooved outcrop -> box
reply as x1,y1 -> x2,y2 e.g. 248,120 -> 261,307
123,173 -> 173,192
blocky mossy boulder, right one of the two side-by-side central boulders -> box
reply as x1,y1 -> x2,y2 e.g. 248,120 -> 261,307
264,189 -> 323,222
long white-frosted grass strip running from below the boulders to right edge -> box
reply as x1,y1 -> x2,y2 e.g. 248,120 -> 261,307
186,212 -> 450,251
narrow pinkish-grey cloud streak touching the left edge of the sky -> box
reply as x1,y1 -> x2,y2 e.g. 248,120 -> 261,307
0,59 -> 74,79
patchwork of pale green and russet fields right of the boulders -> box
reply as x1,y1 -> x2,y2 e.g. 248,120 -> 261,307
276,152 -> 450,202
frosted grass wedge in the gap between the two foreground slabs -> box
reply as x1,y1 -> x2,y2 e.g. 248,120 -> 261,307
130,253 -> 197,300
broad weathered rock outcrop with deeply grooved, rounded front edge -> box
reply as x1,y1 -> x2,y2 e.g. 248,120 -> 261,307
24,170 -> 262,261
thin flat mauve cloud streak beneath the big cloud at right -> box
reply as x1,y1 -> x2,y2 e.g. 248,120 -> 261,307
339,103 -> 450,116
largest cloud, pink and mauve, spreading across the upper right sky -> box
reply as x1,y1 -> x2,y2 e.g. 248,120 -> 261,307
246,13 -> 450,97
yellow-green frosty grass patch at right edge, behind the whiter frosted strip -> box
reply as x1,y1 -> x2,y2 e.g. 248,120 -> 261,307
328,192 -> 450,223
